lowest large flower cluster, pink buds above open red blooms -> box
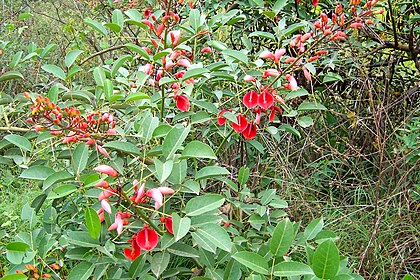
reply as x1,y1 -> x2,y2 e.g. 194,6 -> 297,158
95,165 -> 174,260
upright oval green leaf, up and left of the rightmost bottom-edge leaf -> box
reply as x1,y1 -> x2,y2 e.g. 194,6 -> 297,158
270,219 -> 295,257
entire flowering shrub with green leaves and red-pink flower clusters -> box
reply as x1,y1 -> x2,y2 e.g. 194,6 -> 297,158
2,1 -> 394,279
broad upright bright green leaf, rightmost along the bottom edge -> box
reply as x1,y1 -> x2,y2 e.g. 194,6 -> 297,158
312,240 -> 340,279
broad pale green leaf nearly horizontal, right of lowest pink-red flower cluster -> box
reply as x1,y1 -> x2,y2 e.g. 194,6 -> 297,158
185,194 -> 225,217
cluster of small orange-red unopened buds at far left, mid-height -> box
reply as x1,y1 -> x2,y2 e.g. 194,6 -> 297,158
25,92 -> 116,156
